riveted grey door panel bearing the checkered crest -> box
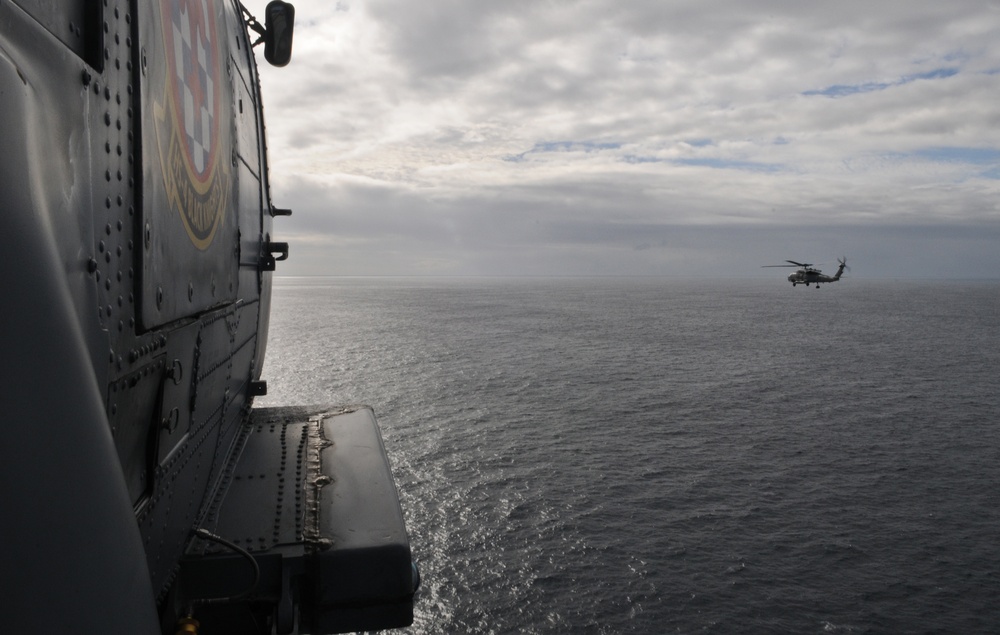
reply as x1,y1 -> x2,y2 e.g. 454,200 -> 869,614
139,0 -> 239,329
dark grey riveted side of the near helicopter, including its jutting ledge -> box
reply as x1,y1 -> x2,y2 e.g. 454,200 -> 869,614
0,0 -> 416,633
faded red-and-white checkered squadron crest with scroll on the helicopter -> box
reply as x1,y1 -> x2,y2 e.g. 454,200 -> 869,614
154,0 -> 232,250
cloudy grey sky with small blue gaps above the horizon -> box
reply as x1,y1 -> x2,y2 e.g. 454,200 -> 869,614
244,0 -> 1000,278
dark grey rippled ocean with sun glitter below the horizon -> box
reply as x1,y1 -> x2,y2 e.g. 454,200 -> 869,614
258,276 -> 1000,634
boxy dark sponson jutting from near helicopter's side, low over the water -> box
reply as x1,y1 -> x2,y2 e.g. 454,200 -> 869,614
179,406 -> 417,633
